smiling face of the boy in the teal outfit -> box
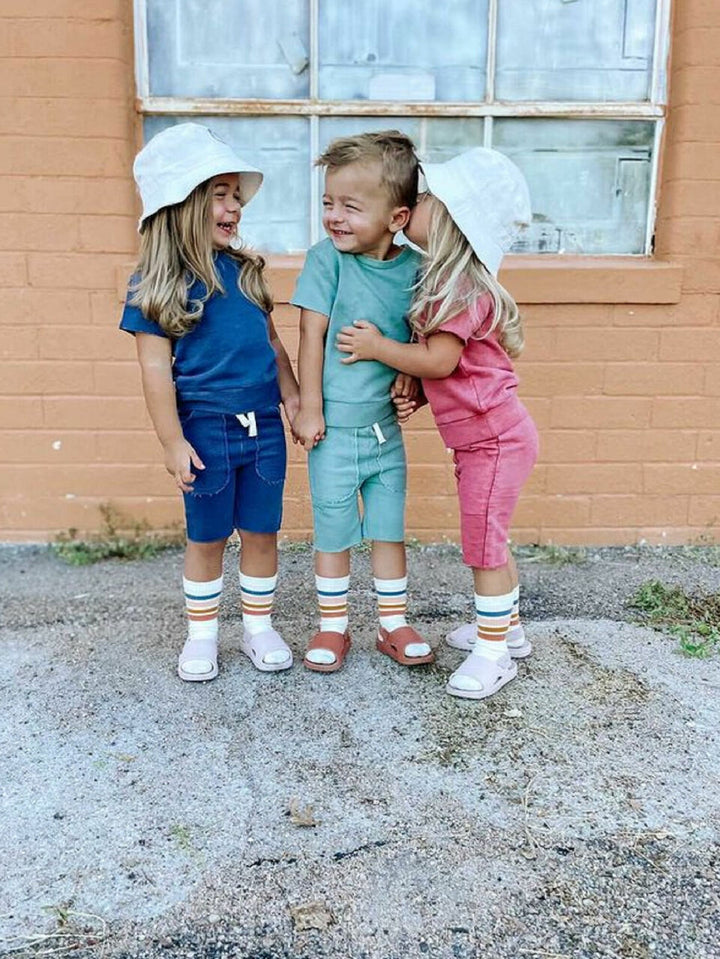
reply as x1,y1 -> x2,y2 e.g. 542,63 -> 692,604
322,162 -> 409,260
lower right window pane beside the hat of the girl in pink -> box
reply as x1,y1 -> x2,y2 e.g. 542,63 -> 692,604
493,119 -> 654,253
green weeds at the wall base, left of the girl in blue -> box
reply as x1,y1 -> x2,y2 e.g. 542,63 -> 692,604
52,503 -> 184,566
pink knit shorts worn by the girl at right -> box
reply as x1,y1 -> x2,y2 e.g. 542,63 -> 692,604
454,414 -> 538,569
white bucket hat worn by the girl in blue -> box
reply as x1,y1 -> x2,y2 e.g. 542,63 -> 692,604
133,123 -> 263,232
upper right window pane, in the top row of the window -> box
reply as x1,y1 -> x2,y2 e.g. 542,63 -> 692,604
495,0 -> 656,101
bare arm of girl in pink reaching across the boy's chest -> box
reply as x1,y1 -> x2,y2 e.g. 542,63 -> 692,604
336,320 -> 463,380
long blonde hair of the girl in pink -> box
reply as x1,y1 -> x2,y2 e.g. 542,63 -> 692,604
408,195 -> 524,357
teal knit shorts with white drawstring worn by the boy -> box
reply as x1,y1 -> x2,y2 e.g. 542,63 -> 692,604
308,416 -> 407,553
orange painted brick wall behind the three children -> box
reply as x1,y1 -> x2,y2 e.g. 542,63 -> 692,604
0,0 -> 720,544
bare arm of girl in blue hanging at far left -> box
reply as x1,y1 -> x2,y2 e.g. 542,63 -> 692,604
135,333 -> 205,493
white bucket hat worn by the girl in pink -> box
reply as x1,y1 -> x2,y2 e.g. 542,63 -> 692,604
422,147 -> 532,276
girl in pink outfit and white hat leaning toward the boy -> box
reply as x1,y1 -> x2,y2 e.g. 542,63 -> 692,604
337,148 -> 538,699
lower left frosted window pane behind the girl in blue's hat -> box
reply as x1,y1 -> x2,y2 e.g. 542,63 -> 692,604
144,117 -> 310,253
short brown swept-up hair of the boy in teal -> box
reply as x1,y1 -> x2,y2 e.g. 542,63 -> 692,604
315,130 -> 419,209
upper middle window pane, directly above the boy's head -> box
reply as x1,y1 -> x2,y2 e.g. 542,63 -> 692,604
318,0 -> 487,101
